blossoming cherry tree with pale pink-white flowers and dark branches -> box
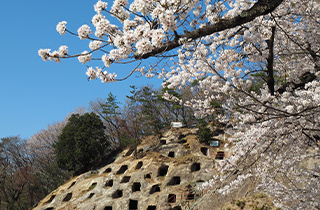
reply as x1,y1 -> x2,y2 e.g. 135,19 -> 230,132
39,0 -> 320,209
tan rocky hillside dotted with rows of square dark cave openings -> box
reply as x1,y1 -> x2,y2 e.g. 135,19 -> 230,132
34,128 -> 229,210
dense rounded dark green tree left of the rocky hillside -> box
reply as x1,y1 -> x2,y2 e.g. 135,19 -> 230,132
53,112 -> 109,174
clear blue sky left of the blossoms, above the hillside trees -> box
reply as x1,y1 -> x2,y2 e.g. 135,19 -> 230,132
0,0 -> 160,138
